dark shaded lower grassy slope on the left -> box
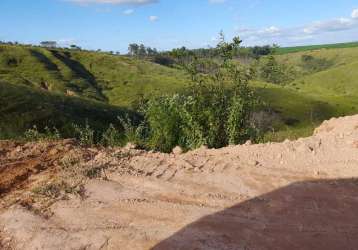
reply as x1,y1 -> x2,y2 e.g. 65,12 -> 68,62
0,82 -> 134,138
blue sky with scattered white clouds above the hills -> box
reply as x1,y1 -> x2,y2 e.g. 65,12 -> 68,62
0,0 -> 358,53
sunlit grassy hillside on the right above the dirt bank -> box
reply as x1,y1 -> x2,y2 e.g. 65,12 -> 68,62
261,48 -> 358,140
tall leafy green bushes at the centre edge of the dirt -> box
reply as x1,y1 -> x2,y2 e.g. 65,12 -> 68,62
144,36 -> 255,152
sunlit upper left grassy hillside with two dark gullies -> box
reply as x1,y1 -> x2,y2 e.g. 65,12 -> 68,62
0,45 -> 186,106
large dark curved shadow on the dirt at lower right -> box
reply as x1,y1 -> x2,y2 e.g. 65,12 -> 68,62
152,179 -> 358,250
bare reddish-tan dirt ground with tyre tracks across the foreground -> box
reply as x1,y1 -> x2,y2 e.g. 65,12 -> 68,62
0,116 -> 358,250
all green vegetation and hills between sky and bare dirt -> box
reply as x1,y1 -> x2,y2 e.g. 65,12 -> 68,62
0,39 -> 358,148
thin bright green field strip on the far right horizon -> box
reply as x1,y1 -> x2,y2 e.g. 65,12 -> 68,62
276,42 -> 358,54
